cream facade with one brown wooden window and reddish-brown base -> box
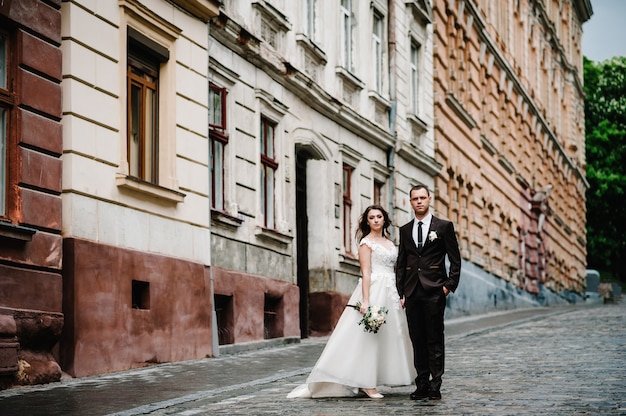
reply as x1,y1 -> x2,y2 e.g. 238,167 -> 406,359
59,0 -> 218,377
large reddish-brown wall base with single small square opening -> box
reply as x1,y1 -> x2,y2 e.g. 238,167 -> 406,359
60,238 -> 213,377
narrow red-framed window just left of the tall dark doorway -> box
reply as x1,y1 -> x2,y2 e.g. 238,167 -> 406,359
260,117 -> 278,229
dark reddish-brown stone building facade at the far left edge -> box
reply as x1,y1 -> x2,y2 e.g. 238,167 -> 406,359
0,0 -> 63,388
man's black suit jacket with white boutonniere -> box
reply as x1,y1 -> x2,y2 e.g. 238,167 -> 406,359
396,216 -> 461,298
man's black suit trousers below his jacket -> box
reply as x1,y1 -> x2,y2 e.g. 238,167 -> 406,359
405,290 -> 446,391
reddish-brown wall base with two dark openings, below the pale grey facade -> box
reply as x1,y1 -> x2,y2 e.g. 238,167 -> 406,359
213,267 -> 300,344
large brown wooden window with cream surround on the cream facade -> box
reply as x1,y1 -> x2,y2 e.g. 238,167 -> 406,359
116,9 -> 182,204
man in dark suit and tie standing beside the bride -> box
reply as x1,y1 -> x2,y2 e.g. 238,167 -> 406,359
396,185 -> 461,400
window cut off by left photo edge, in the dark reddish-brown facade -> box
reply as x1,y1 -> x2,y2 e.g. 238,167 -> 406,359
0,32 -> 13,217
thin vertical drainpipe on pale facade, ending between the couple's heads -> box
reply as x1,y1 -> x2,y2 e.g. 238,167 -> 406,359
387,0 -> 398,231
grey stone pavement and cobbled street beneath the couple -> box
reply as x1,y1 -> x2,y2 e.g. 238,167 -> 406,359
0,302 -> 626,416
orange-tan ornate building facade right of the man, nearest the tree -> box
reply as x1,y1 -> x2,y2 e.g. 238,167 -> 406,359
433,0 -> 592,312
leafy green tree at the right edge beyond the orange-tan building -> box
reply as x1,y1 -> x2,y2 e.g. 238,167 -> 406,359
583,57 -> 626,282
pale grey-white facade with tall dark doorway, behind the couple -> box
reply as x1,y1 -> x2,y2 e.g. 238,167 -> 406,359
209,0 -> 440,344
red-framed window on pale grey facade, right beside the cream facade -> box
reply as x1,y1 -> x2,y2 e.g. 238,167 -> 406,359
209,84 -> 228,211
